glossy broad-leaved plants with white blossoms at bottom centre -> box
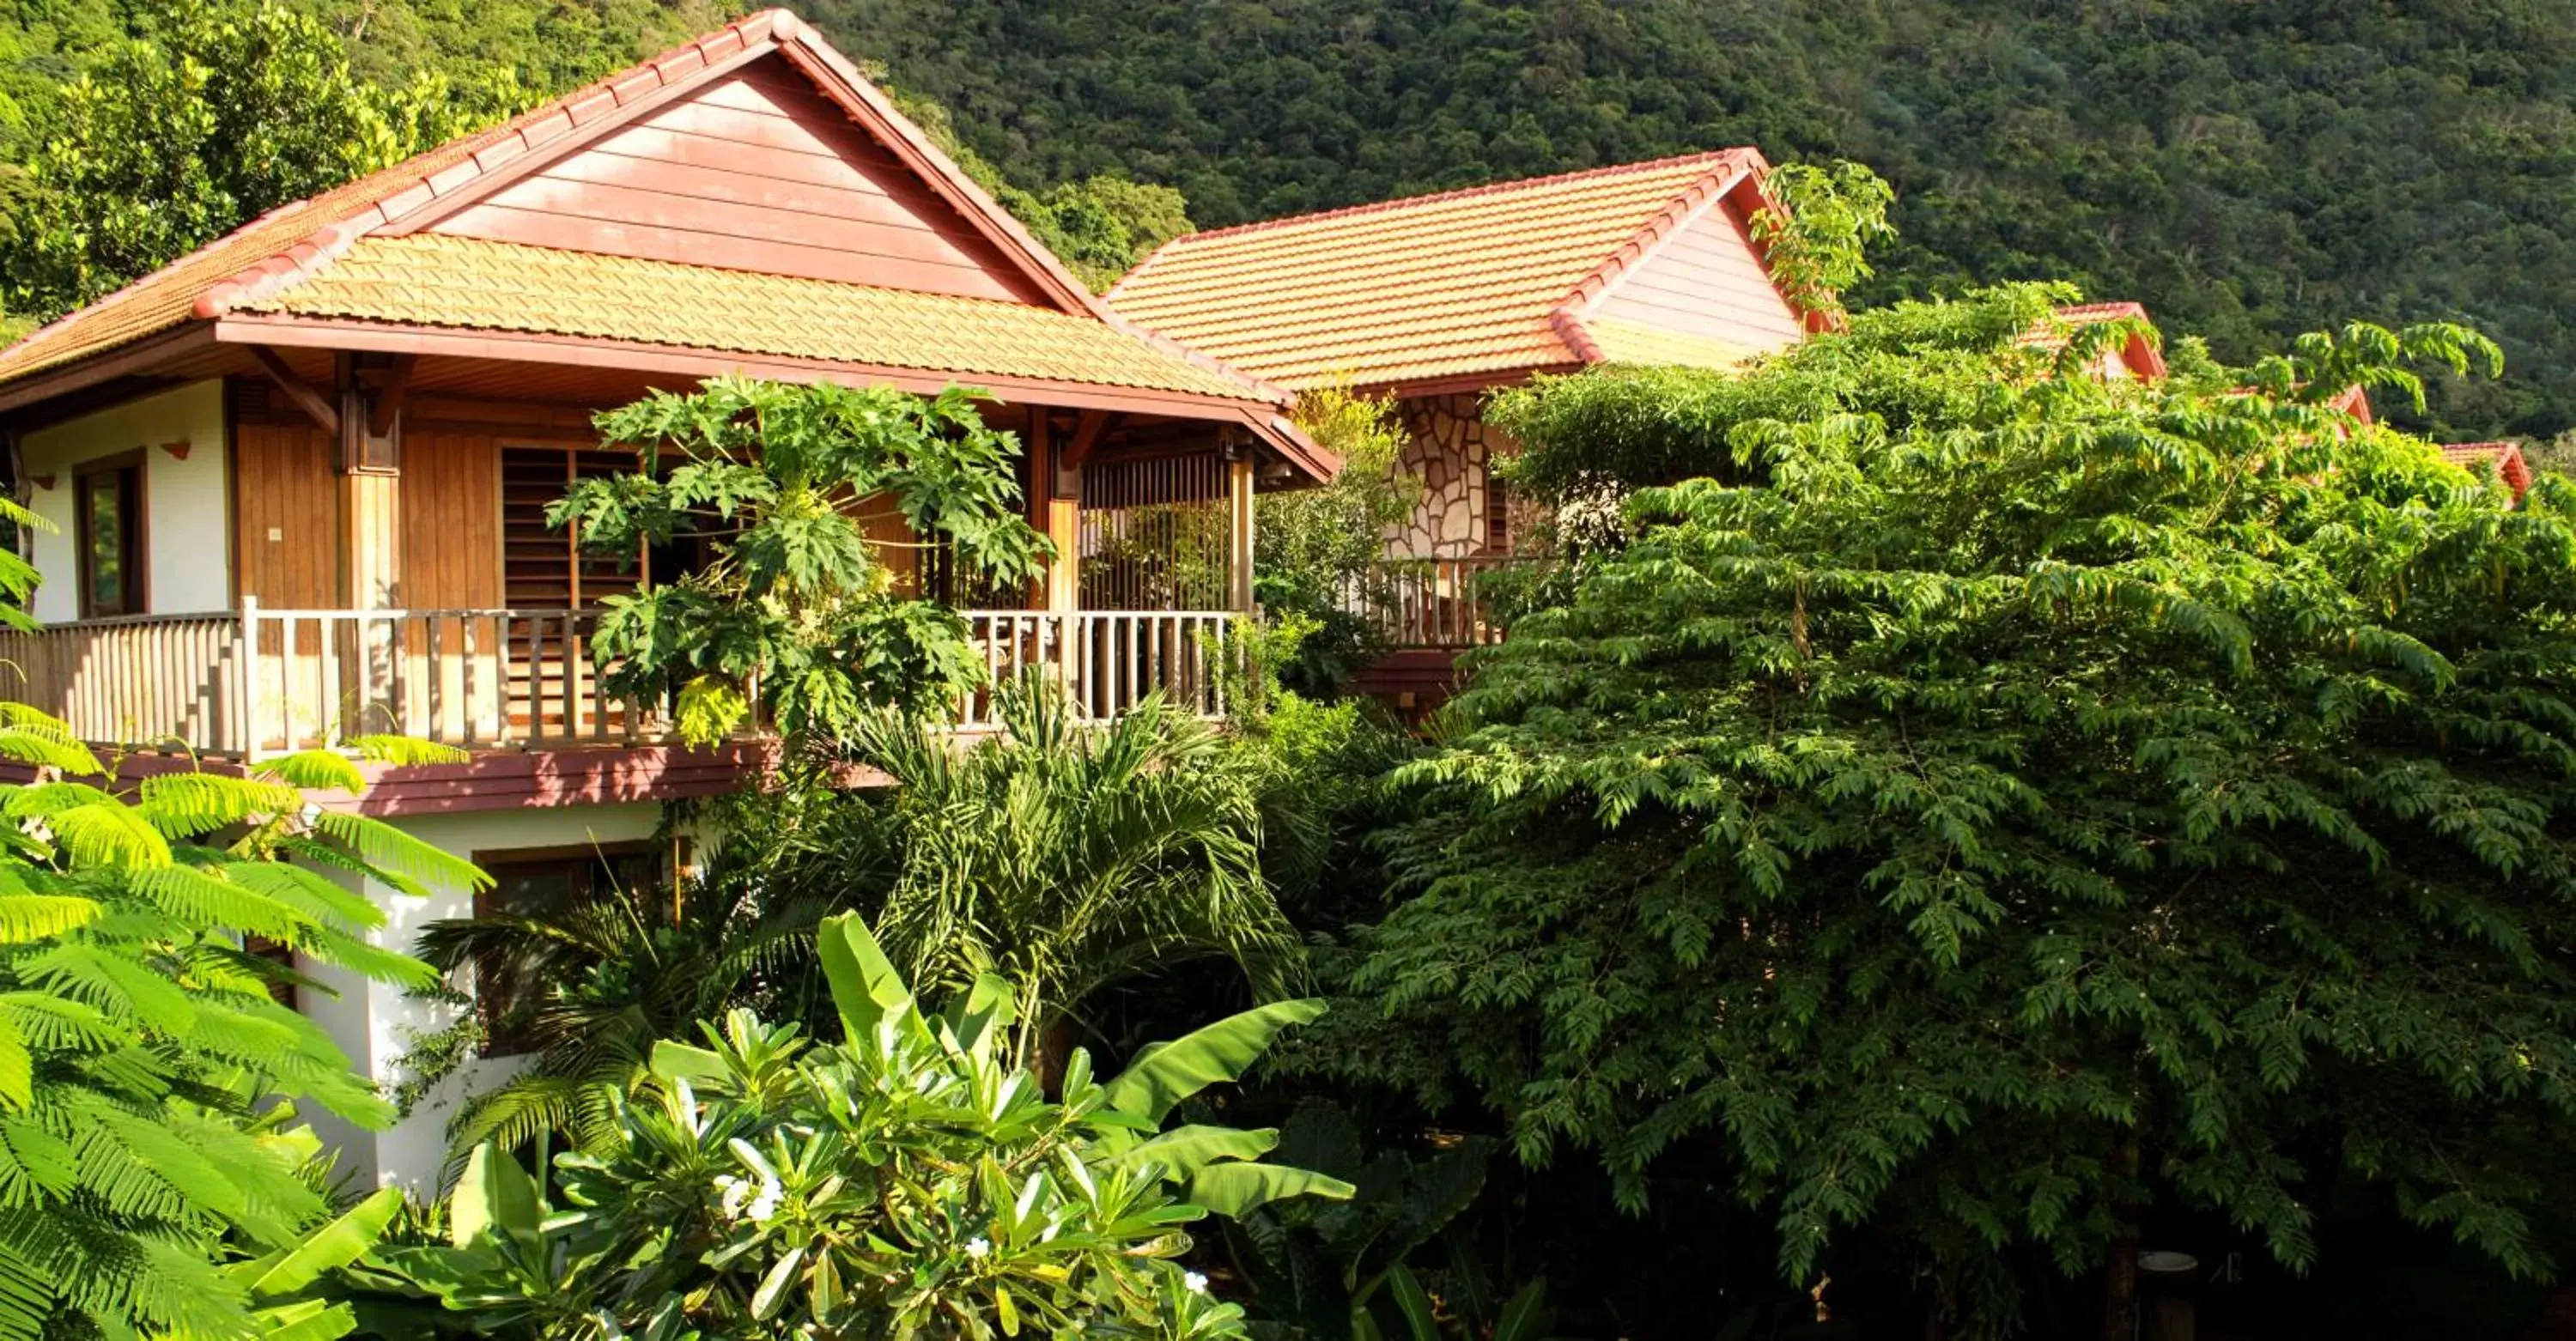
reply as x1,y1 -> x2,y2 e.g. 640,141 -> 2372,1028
371,916 -> 1350,1341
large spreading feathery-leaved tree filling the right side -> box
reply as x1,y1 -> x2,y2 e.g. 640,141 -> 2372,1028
1303,294 -> 2576,1336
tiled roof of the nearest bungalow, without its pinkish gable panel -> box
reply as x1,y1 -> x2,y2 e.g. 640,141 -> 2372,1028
0,10 -> 1311,416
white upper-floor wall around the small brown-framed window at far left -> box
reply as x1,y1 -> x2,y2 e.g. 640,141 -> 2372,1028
18,381 -> 232,623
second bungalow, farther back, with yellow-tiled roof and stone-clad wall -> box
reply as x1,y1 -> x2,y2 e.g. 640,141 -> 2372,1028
1110,149 -> 1808,561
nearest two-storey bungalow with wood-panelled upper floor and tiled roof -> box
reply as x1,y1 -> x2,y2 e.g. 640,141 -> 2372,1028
0,10 -> 1337,1179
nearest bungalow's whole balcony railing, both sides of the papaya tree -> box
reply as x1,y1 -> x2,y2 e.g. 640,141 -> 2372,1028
0,603 -> 1242,759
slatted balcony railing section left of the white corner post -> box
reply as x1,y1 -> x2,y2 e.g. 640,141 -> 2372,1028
0,610 -> 242,751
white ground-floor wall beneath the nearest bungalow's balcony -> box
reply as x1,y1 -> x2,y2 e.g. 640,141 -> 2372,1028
299,800 -> 662,1197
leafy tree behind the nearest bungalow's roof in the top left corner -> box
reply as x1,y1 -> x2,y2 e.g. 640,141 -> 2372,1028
5,0 -> 523,314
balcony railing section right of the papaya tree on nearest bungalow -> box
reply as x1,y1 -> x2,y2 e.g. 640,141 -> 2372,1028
958,610 -> 1247,725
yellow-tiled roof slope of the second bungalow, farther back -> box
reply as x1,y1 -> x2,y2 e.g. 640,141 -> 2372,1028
1110,149 -> 1759,386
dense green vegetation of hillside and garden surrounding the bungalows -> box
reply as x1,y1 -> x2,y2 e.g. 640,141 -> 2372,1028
0,0 -> 2576,1341
